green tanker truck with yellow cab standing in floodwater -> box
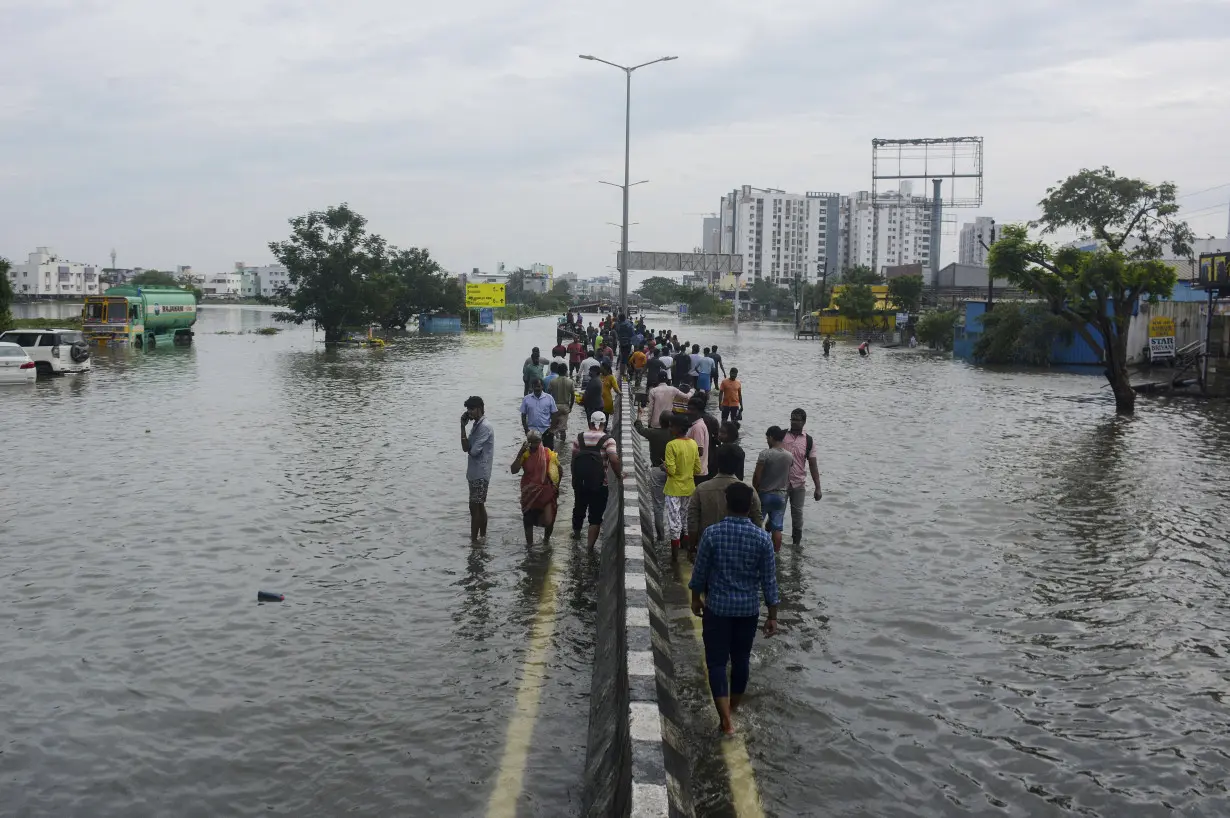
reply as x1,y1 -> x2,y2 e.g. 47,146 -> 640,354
81,284 -> 197,349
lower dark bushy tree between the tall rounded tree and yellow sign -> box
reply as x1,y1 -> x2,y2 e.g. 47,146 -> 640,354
371,247 -> 465,330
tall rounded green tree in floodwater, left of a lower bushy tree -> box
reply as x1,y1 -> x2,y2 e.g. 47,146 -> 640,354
269,203 -> 387,343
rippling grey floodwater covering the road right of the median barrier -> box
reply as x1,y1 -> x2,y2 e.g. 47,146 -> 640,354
673,326 -> 1230,818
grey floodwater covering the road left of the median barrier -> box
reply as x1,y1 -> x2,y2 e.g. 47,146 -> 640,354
0,305 -> 597,818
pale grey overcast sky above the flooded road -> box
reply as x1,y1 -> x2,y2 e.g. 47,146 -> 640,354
0,0 -> 1230,276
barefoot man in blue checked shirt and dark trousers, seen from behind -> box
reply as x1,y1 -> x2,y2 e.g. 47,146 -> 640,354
688,482 -> 780,736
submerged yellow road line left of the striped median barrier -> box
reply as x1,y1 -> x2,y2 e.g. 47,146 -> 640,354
487,544 -> 560,818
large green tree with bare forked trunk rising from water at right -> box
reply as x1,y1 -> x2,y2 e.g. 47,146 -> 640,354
988,167 -> 1194,415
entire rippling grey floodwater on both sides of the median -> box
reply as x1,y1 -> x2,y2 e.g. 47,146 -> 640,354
0,306 -> 1230,818
